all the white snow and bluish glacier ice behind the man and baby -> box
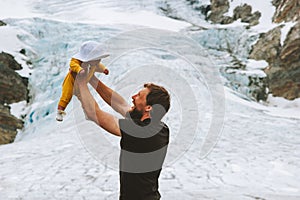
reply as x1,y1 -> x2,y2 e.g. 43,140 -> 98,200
0,0 -> 300,200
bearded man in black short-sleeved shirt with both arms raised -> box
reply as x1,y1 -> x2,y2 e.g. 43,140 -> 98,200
76,73 -> 170,200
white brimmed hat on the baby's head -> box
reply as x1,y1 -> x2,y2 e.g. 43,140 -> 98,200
73,41 -> 109,62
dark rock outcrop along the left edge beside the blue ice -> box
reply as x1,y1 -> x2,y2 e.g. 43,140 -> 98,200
0,52 -> 28,144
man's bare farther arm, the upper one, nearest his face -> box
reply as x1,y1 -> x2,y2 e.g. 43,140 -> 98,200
90,75 -> 130,116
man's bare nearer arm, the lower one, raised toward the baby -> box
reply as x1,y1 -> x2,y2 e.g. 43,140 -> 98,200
75,73 -> 121,136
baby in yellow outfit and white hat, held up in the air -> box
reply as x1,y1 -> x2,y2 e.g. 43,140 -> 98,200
56,41 -> 109,121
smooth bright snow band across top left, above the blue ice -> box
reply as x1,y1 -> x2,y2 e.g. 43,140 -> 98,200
0,0 -> 190,31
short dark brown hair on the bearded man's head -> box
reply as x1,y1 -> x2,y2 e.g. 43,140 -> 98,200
144,83 -> 170,120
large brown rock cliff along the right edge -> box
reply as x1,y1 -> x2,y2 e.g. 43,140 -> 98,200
250,0 -> 300,100
